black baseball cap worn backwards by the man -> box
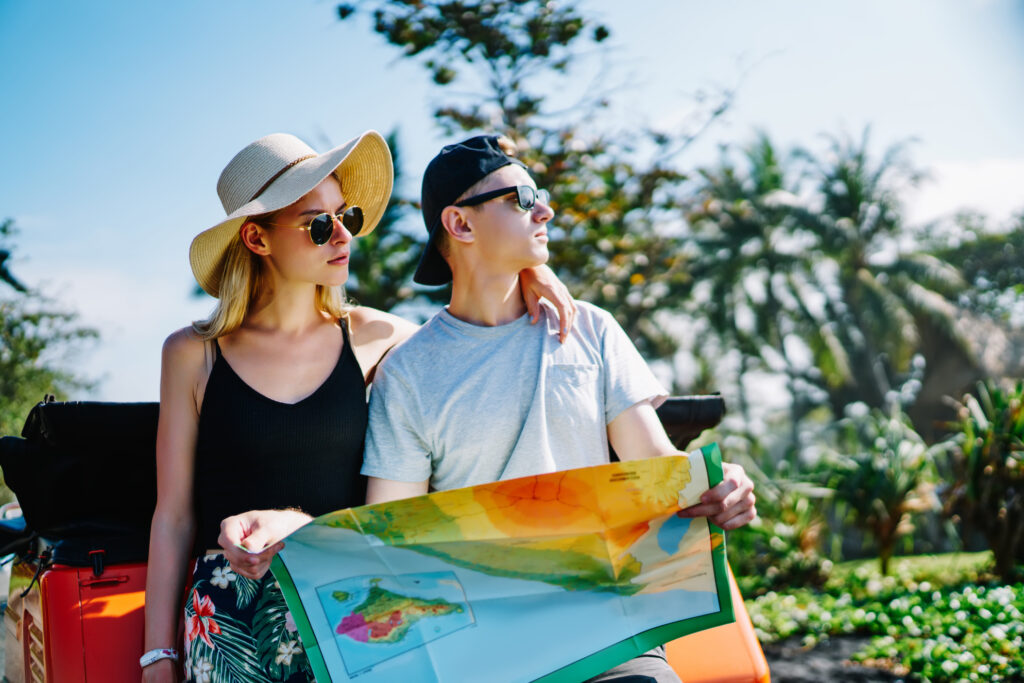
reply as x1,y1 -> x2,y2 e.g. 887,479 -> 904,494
413,135 -> 526,285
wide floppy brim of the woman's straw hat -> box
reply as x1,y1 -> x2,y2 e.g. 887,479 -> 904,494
188,130 -> 394,297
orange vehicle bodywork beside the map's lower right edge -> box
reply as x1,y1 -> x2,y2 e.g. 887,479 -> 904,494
665,569 -> 771,683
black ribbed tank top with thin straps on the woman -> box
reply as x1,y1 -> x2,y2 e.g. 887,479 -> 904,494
194,323 -> 367,553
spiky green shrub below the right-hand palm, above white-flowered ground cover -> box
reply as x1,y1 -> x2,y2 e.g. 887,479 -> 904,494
826,407 -> 939,575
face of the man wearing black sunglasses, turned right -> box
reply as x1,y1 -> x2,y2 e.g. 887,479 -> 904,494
465,164 -> 555,273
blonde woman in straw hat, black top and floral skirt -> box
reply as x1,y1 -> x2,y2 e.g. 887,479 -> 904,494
140,131 -> 574,683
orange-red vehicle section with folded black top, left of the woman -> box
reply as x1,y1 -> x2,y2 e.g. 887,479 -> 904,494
0,402 -> 159,683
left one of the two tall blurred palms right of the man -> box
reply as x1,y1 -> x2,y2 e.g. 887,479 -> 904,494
688,133 -> 812,446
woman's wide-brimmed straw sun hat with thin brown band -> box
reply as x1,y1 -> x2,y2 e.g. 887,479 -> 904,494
188,130 -> 393,297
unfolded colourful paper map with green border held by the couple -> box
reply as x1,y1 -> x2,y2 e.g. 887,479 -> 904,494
272,444 -> 733,683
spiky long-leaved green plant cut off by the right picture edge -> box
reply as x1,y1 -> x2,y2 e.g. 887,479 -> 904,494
946,382 -> 1024,581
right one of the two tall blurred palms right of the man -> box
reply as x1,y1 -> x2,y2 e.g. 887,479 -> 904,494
793,129 -> 970,415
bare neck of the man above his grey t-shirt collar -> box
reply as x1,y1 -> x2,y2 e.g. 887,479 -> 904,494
447,271 -> 526,327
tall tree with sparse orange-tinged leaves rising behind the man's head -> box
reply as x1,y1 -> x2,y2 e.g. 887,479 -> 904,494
338,0 -> 728,357
